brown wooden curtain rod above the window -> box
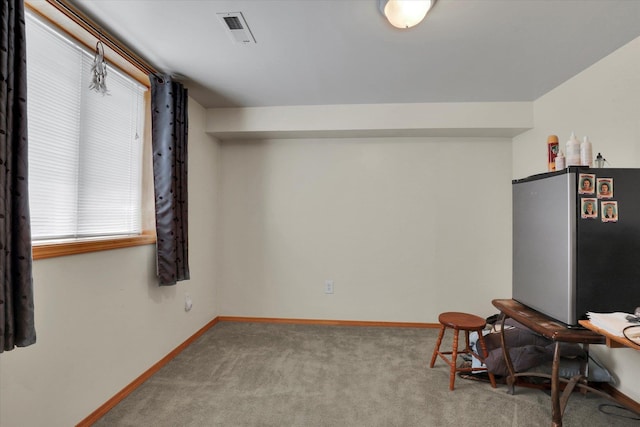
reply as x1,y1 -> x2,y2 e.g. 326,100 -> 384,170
47,0 -> 159,74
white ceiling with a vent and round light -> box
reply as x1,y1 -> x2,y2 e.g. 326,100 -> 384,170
73,0 -> 640,108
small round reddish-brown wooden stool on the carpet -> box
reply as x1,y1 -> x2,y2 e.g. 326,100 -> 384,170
429,312 -> 496,390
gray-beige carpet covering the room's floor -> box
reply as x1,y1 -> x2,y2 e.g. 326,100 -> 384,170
95,322 -> 640,427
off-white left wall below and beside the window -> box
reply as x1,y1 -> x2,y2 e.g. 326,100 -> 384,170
0,98 -> 218,427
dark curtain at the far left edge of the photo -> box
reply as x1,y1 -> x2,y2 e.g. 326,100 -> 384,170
0,0 -> 36,352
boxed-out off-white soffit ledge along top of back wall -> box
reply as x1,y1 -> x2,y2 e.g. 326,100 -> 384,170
205,102 -> 533,141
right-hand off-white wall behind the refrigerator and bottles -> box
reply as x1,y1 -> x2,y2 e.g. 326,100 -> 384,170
513,38 -> 640,401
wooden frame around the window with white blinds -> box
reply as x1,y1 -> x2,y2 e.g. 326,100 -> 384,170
25,0 -> 156,260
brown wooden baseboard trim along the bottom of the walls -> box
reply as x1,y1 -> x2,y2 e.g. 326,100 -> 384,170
76,316 -> 640,427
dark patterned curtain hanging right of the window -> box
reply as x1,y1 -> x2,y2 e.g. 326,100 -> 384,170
149,74 -> 189,286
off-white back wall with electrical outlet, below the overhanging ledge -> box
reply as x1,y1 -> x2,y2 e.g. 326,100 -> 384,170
219,138 -> 511,322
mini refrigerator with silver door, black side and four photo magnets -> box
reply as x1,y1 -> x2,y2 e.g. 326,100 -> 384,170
512,167 -> 640,326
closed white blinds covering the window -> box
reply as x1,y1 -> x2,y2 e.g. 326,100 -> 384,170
26,13 -> 147,241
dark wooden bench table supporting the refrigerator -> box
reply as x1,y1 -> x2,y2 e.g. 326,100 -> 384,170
492,299 -> 615,427
